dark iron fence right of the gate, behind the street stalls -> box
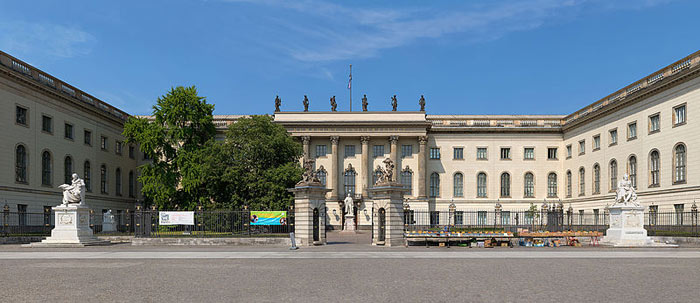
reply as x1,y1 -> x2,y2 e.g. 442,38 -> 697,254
404,209 -> 700,237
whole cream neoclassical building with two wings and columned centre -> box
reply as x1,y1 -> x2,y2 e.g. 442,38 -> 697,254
0,52 -> 700,226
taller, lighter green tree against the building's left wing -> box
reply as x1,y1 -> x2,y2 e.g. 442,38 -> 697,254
123,86 -> 216,209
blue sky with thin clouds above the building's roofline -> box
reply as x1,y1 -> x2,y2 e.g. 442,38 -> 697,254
0,0 -> 700,114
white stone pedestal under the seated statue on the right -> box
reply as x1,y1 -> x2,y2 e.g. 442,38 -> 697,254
601,205 -> 677,247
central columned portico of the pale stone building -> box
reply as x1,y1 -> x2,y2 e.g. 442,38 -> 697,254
275,111 -> 431,229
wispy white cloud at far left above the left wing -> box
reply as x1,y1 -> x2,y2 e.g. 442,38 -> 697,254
0,20 -> 97,58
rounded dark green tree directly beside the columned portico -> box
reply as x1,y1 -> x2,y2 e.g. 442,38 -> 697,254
204,115 -> 302,210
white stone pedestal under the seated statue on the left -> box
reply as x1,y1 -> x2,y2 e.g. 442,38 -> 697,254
26,204 -> 110,247
